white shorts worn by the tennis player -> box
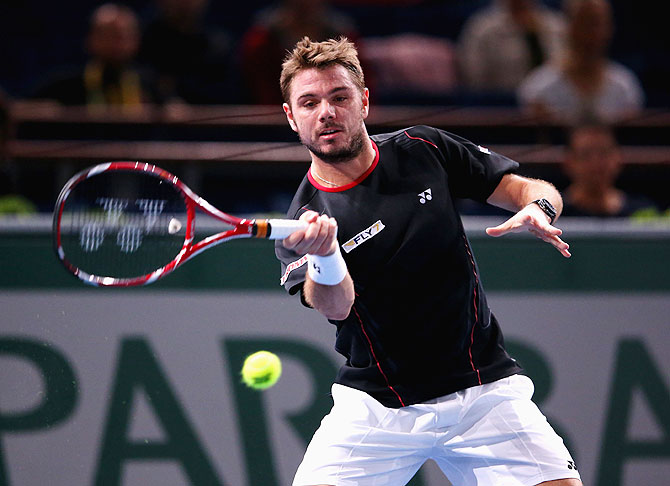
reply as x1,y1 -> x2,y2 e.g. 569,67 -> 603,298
293,375 -> 579,486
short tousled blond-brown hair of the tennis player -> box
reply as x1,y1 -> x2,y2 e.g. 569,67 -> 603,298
279,37 -> 365,103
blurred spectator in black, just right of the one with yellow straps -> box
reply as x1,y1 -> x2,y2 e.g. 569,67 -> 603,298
139,0 -> 236,104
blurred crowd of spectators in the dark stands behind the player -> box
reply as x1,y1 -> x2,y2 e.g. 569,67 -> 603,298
0,0 -> 670,216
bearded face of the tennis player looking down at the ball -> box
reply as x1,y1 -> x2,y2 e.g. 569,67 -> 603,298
284,64 -> 368,163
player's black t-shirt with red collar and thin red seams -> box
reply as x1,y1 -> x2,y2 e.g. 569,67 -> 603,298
276,126 -> 521,407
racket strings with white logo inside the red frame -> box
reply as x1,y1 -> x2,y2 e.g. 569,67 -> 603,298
60,171 -> 188,279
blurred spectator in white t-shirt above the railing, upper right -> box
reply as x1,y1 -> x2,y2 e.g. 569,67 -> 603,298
518,0 -> 644,123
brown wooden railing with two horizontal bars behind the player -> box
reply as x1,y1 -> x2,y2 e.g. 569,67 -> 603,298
8,101 -> 670,166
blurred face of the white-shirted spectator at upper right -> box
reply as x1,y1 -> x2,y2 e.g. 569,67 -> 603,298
569,0 -> 613,56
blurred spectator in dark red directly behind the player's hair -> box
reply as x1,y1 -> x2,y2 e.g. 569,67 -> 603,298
241,0 -> 358,105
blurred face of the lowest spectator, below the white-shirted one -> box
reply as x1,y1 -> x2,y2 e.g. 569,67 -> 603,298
565,126 -> 621,188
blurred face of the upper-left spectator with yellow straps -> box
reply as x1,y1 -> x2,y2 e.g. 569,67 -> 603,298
88,4 -> 140,66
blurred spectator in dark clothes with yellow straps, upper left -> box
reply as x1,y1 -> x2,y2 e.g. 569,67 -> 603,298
35,3 -> 158,108
